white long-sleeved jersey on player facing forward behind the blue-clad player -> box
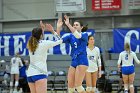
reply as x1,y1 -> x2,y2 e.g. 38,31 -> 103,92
87,47 -> 101,72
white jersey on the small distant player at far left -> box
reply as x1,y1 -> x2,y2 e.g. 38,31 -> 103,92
11,57 -> 23,74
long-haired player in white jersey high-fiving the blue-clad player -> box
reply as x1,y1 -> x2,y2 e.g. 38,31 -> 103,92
27,19 -> 62,93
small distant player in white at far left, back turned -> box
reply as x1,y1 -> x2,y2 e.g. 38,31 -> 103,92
10,53 -> 23,91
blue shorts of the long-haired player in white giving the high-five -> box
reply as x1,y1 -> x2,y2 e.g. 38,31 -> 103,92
27,74 -> 48,83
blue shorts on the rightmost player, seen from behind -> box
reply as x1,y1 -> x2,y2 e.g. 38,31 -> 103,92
121,66 -> 135,75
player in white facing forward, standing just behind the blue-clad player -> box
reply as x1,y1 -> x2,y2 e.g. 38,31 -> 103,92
86,36 -> 101,93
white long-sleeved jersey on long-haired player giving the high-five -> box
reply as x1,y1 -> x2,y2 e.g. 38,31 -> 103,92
27,40 -> 62,77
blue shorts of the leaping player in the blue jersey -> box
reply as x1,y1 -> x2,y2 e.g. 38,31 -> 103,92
71,55 -> 88,68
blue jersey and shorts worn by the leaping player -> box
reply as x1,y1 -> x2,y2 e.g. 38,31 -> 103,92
62,32 -> 88,67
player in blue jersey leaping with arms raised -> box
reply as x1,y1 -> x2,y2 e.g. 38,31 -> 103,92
57,15 -> 90,93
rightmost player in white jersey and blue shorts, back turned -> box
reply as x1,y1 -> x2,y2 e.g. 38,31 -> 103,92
118,43 -> 140,93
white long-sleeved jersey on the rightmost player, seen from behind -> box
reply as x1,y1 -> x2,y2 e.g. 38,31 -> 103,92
118,51 -> 140,67
